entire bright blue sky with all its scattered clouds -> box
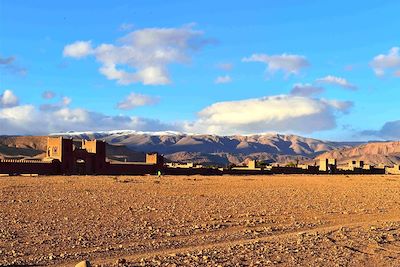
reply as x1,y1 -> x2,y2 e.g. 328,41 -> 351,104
0,0 -> 400,140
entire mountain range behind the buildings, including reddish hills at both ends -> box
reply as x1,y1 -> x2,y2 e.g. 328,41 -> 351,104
0,130 -> 400,166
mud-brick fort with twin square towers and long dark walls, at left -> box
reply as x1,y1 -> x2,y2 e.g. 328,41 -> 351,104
0,137 -> 164,175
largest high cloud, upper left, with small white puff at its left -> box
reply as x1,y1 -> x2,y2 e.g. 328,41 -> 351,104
64,25 -> 208,85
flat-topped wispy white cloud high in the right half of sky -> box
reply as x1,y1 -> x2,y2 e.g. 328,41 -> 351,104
242,54 -> 310,76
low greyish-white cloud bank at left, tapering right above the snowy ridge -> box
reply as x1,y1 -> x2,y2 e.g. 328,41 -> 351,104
0,105 -> 180,135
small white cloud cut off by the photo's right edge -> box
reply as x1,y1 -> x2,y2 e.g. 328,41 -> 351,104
370,47 -> 400,76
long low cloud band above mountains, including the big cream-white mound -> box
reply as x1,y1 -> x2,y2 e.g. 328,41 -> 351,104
0,91 -> 352,135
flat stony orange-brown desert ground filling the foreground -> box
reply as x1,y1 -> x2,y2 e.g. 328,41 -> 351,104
0,175 -> 400,266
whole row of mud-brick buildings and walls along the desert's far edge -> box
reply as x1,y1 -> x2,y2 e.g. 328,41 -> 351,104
0,137 -> 400,175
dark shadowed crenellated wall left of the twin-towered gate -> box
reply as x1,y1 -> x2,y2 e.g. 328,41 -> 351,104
0,160 -> 61,175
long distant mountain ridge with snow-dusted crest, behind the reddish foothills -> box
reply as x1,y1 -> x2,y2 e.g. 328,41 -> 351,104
49,130 -> 359,166
